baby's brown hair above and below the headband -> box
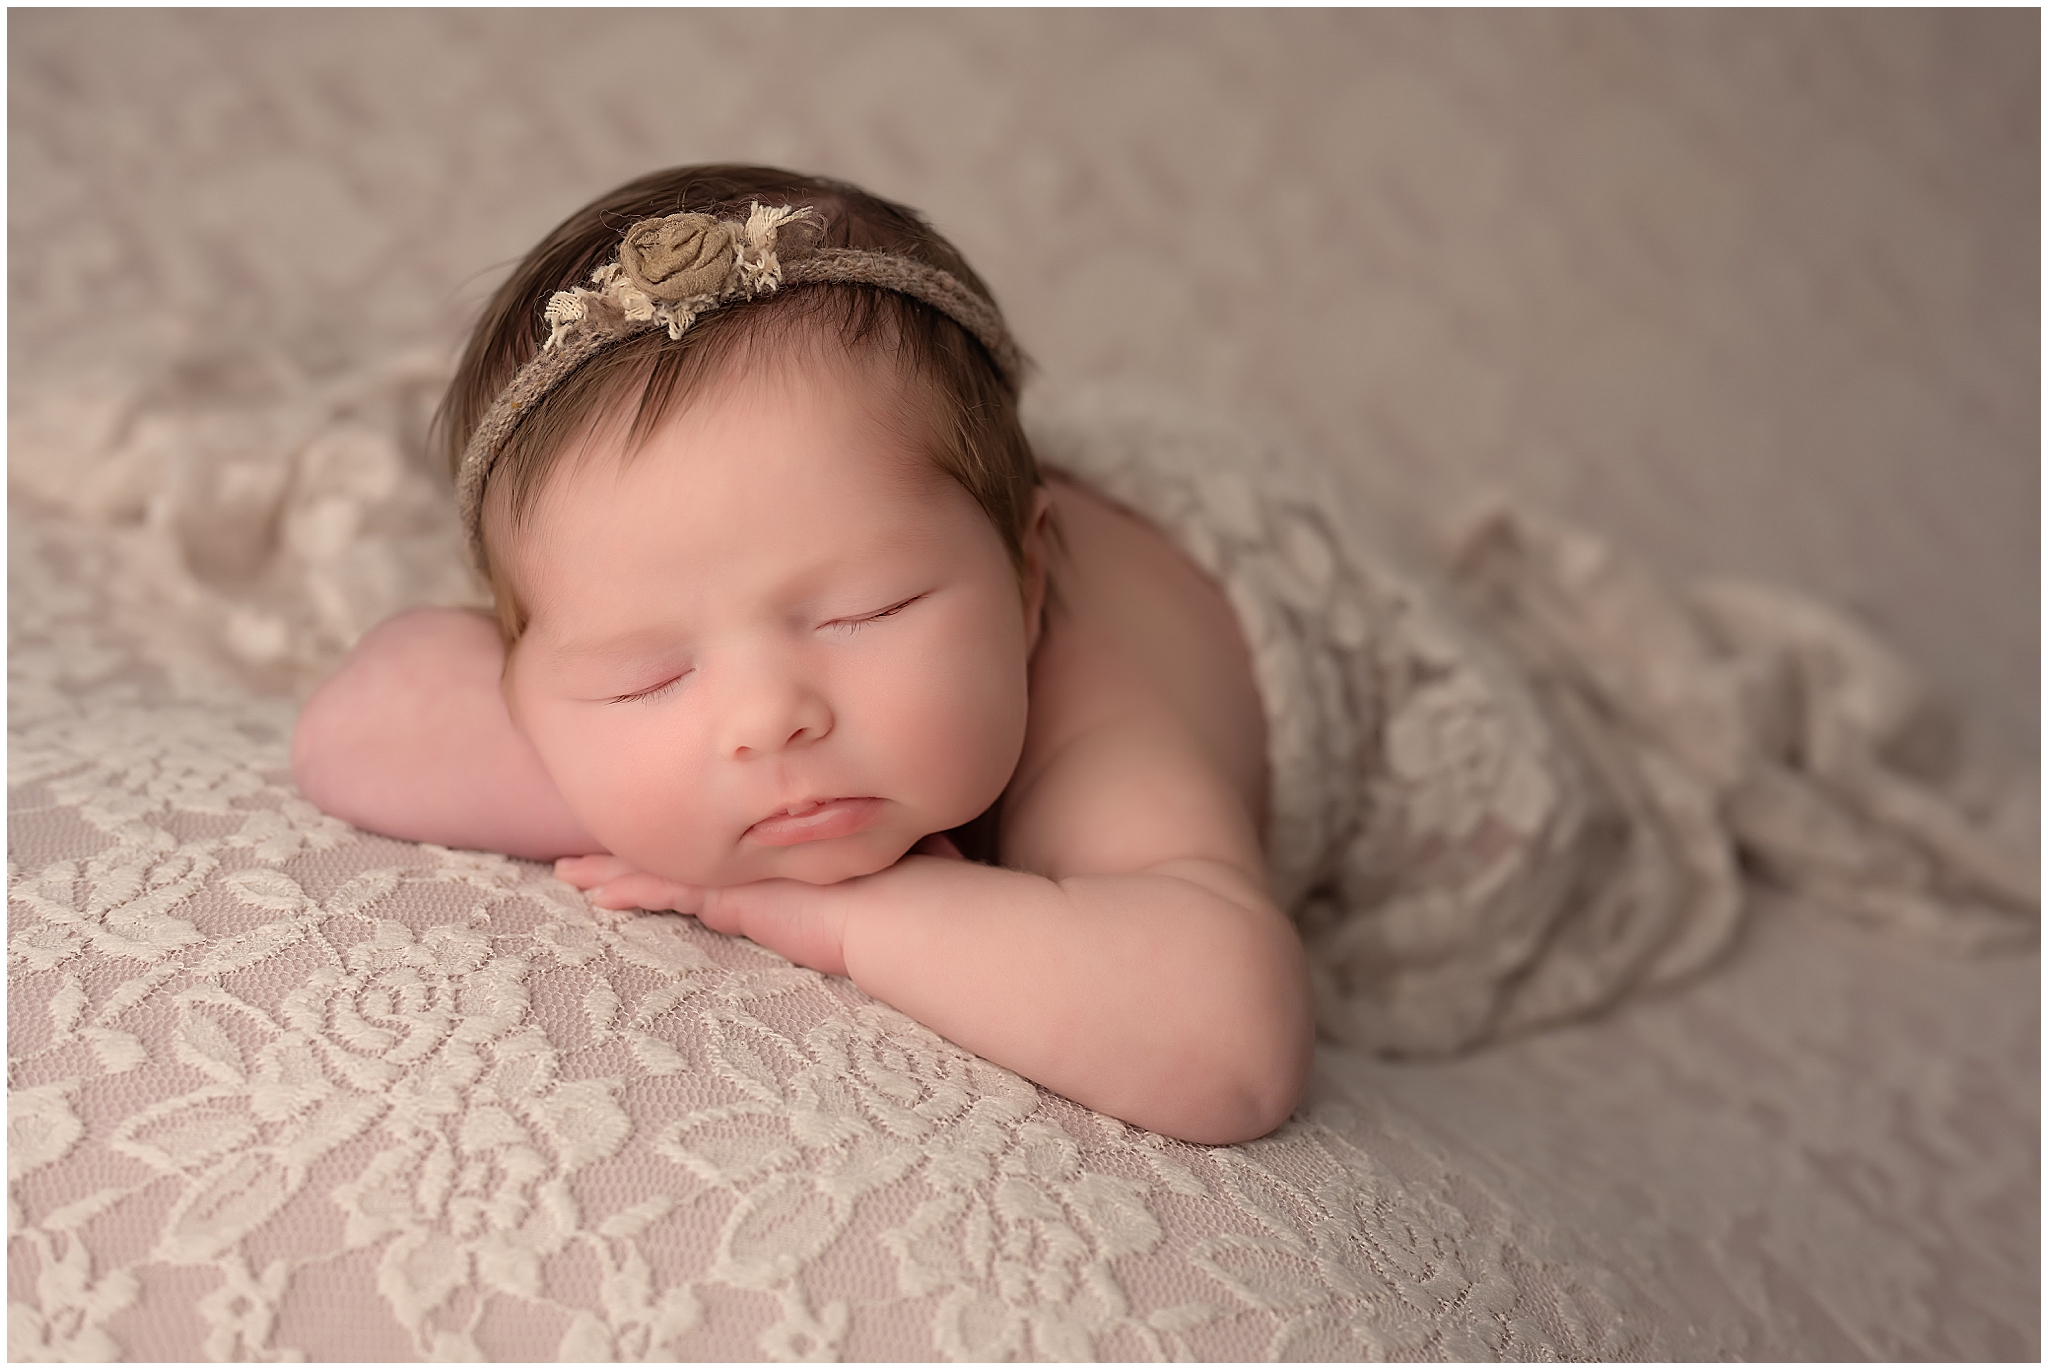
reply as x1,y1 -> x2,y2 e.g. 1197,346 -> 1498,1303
432,166 -> 1038,647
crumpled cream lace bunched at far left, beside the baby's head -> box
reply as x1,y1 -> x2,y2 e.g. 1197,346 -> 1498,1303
8,346 -> 471,696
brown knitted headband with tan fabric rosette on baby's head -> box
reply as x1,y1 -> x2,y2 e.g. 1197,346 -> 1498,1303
455,205 -> 1024,571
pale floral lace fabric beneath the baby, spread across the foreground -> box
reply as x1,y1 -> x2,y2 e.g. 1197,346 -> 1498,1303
8,444 -> 2038,1360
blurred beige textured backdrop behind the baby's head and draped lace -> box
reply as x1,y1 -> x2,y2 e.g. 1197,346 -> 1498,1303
8,10 -> 2040,752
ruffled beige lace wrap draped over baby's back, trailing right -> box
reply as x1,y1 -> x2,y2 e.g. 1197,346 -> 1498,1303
1040,397 -> 2040,1055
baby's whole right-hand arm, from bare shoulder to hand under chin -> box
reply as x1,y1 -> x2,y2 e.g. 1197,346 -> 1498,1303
557,483 -> 1315,1143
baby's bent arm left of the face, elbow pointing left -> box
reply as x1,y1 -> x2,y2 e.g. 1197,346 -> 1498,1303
291,608 -> 604,860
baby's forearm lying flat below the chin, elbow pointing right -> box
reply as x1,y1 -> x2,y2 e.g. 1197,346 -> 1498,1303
707,856 -> 1315,1143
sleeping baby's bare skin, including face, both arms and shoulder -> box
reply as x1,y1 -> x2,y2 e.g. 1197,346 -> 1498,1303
293,344 -> 1313,1145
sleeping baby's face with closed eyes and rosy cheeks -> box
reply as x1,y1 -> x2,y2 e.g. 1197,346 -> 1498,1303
500,350 -> 1042,885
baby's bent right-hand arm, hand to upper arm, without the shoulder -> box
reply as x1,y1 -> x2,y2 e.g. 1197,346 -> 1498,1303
561,721 -> 1315,1145
